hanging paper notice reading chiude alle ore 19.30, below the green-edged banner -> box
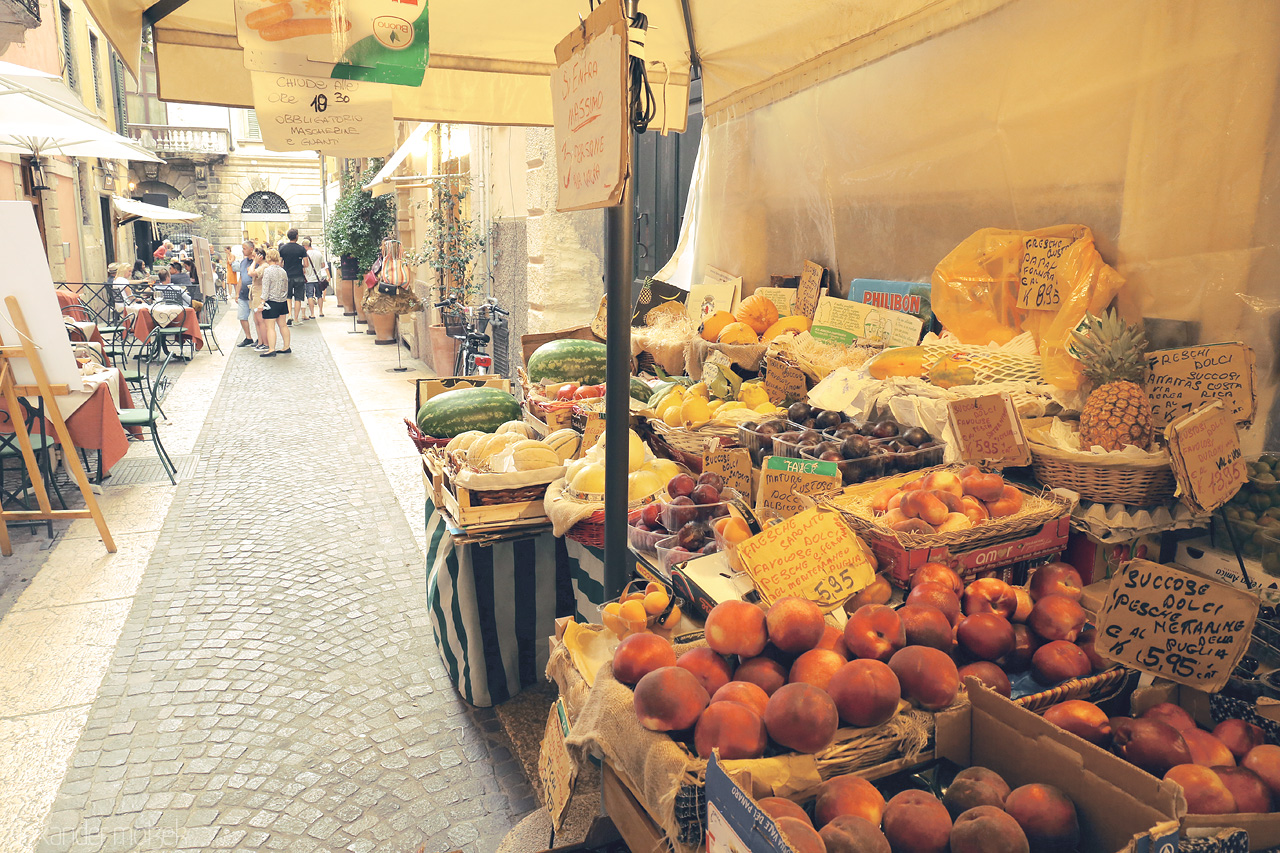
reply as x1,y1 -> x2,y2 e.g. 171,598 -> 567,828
251,72 -> 396,158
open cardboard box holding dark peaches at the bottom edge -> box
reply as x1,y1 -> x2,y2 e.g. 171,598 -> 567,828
707,688 -> 1185,853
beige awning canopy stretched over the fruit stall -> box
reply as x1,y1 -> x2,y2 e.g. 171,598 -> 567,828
86,0 -> 1009,129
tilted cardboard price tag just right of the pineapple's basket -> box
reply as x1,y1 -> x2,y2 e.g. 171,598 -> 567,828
1165,401 -> 1247,514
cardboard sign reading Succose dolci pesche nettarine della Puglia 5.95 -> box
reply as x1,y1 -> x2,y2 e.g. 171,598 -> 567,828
1090,558 -> 1258,693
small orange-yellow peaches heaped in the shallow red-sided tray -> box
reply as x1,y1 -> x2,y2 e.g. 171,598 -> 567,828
872,465 -> 1023,533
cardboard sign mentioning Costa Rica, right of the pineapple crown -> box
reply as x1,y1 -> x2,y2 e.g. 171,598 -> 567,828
1147,343 -> 1257,427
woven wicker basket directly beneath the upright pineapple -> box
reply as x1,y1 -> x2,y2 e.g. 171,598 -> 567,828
1028,442 -> 1176,506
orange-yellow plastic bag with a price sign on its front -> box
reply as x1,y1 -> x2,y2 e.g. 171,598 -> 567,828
931,225 -> 1124,389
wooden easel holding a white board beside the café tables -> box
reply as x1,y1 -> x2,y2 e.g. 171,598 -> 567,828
0,296 -> 115,557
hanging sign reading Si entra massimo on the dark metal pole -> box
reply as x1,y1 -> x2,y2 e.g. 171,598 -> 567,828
552,0 -> 631,210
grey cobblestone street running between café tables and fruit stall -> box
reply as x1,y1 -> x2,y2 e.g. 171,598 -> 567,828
5,318 -> 536,853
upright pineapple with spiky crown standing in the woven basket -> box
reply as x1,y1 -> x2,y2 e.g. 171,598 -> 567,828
1071,311 -> 1155,451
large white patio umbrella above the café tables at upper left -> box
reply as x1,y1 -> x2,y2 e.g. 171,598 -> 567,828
0,63 -> 164,163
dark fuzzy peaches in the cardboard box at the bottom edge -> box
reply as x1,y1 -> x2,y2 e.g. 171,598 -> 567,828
759,767 -> 1080,853
